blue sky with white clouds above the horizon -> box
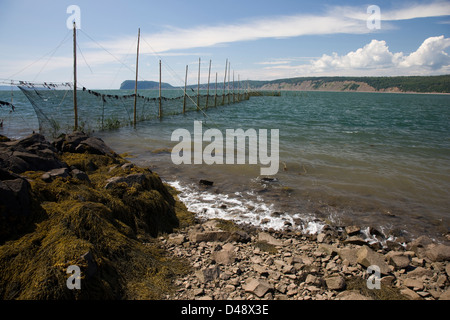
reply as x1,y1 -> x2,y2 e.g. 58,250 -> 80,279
0,0 -> 450,89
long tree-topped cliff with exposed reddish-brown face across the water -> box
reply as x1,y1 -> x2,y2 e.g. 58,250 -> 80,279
248,75 -> 450,93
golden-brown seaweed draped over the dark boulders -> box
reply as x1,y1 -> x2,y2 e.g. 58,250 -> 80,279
0,134 -> 192,299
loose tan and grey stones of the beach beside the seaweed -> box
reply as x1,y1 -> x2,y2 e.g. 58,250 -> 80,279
160,220 -> 450,300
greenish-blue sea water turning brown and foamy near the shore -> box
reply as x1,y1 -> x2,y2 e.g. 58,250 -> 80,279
0,92 -> 450,239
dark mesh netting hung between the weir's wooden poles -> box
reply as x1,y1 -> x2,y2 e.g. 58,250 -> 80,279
19,83 -> 249,137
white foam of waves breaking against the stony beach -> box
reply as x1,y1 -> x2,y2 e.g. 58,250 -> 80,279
168,181 -> 324,234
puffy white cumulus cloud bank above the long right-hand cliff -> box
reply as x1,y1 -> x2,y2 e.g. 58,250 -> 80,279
245,36 -> 450,80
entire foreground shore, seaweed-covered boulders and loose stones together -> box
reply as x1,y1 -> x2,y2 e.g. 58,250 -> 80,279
0,133 -> 450,300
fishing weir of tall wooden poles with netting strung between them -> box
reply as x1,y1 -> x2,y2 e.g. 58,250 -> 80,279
0,23 -> 281,137
